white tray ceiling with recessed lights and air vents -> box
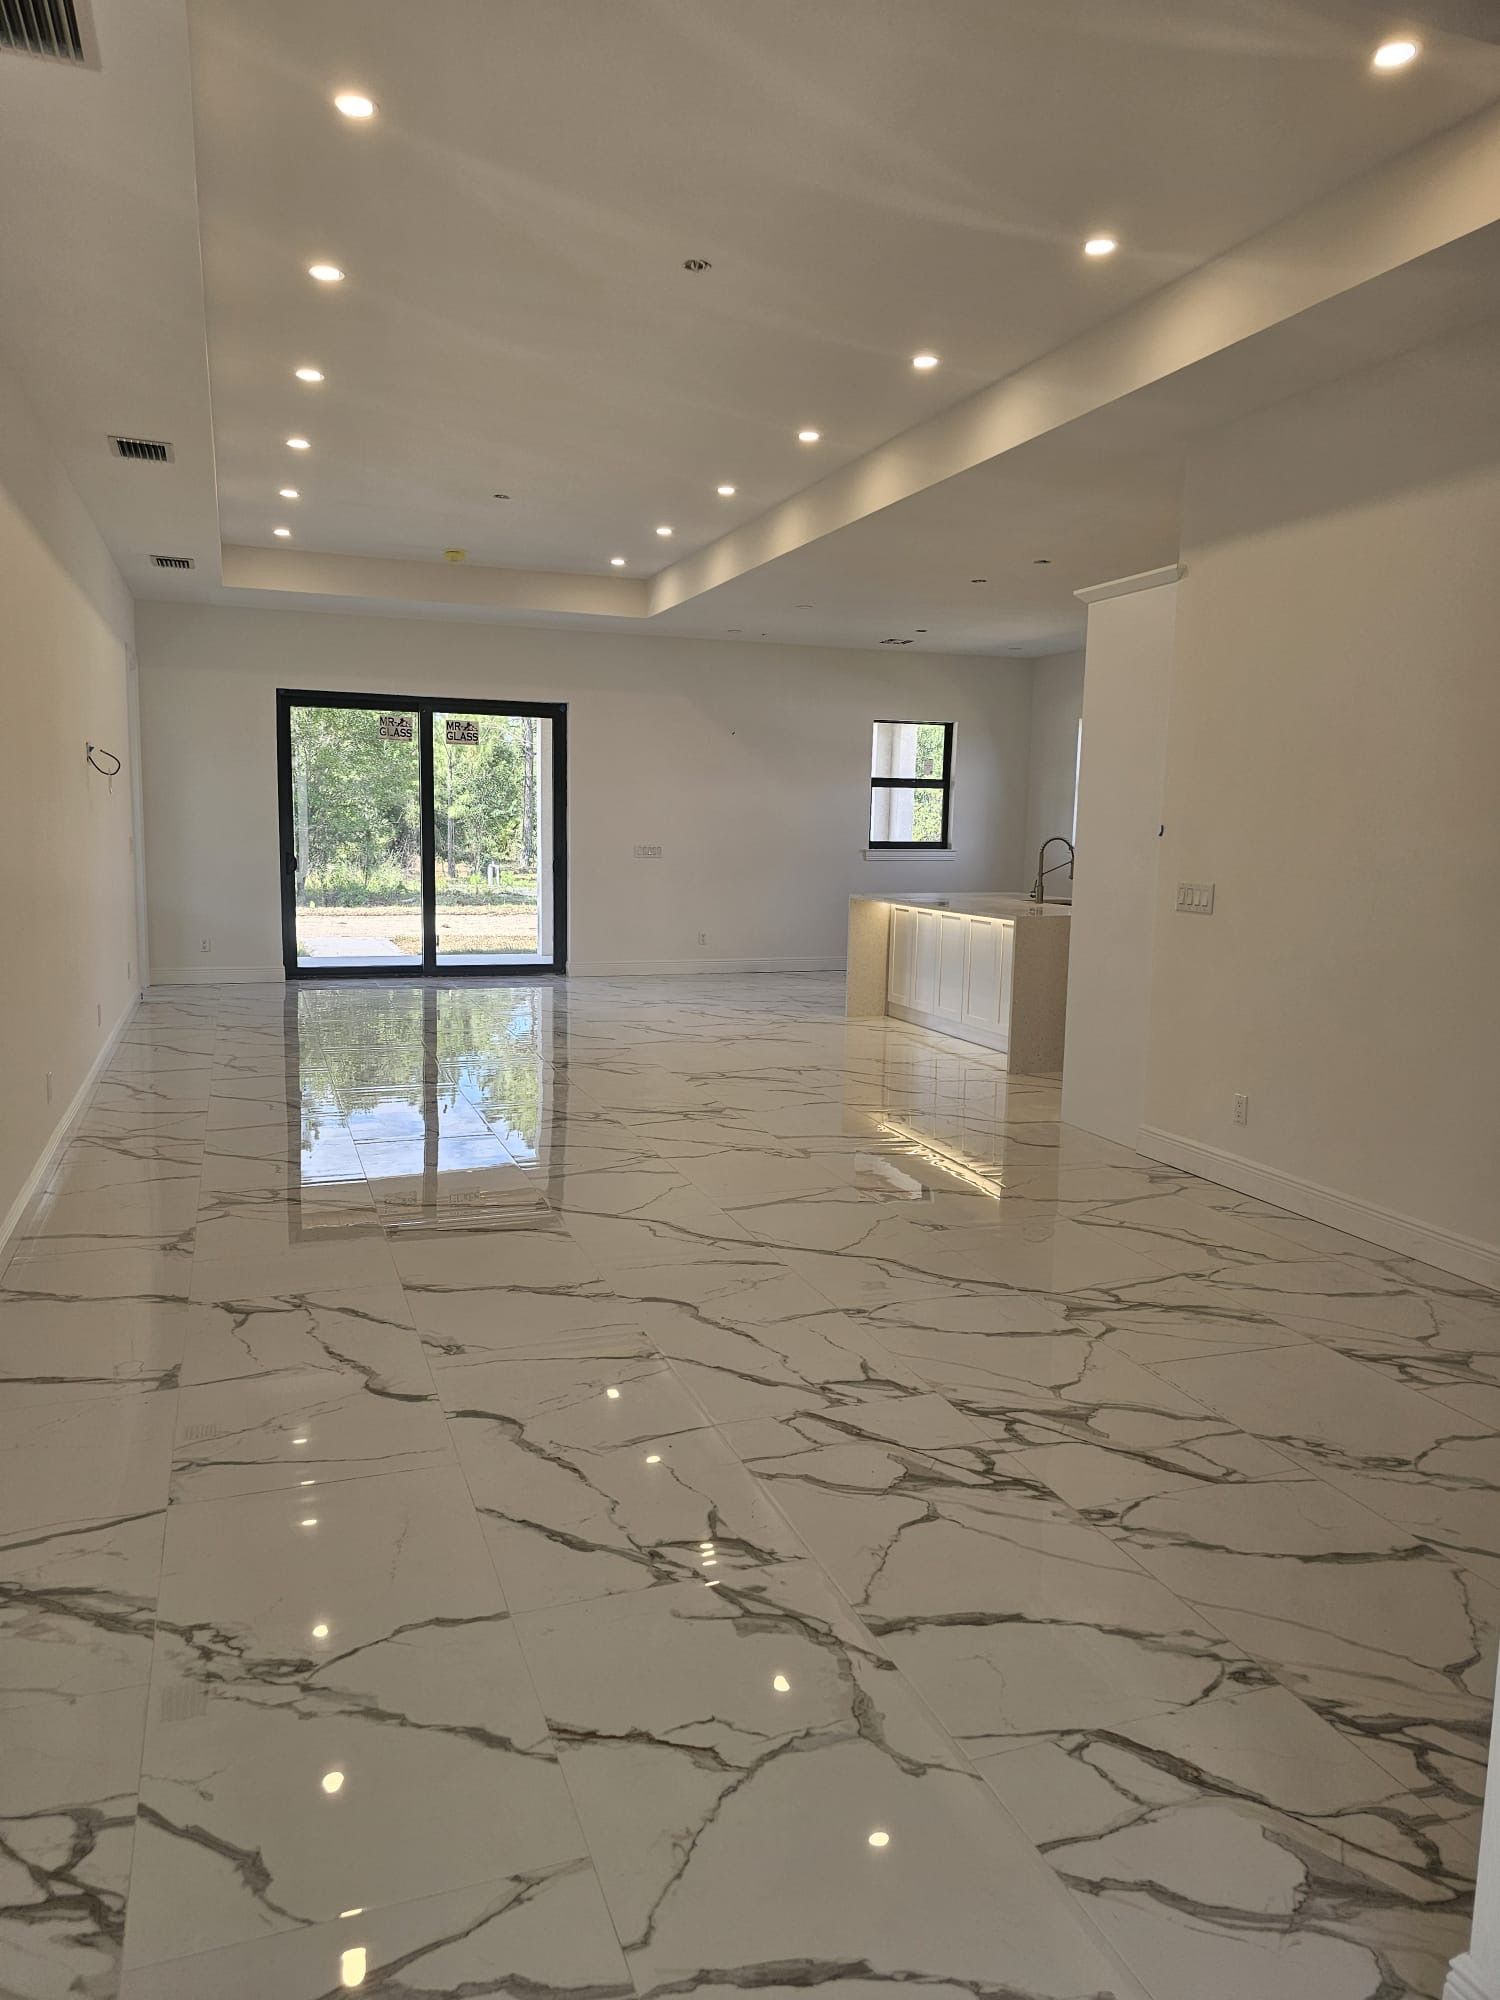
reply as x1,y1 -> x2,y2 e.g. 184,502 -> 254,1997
0,0 -> 1500,652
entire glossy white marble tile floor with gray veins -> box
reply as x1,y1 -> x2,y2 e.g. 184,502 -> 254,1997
0,976 -> 1500,2000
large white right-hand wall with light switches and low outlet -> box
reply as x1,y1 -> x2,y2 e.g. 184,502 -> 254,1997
1144,324 -> 1500,1280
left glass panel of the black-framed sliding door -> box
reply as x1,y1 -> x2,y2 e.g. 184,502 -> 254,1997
284,702 -> 422,972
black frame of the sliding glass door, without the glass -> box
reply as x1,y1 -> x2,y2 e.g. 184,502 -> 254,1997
276,688 -> 568,980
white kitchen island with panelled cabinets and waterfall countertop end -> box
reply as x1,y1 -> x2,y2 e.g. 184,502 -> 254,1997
844,894 -> 1072,1076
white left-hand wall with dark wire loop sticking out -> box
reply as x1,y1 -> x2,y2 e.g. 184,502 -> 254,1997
0,350 -> 138,1246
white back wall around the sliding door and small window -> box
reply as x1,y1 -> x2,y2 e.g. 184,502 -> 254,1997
138,604 -> 1030,980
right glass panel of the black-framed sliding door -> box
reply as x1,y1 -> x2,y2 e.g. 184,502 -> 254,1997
432,708 -> 552,966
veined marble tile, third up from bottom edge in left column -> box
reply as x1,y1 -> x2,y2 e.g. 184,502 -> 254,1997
172,1286 -> 452,1500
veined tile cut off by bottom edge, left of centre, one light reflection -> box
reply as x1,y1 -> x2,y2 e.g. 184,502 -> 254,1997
120,1860 -> 634,2000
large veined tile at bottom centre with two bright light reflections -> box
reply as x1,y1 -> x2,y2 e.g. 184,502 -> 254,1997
518,1564 -> 1136,2000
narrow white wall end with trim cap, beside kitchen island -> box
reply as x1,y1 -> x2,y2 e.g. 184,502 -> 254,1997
1062,582 -> 1182,1146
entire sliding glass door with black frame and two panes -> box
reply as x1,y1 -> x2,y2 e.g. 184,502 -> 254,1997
276,688 -> 566,978
